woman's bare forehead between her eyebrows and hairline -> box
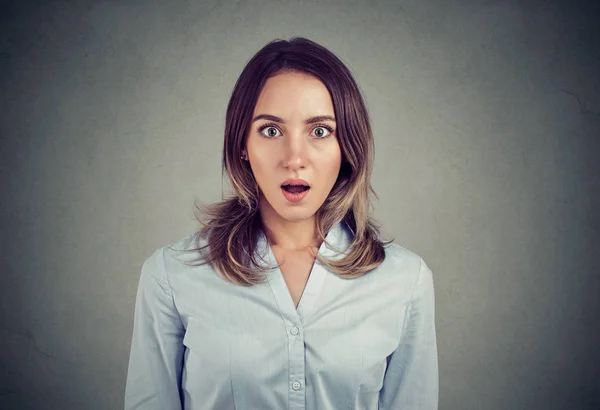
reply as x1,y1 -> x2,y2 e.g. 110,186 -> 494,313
254,73 -> 334,120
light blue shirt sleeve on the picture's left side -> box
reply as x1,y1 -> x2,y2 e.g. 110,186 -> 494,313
125,249 -> 185,410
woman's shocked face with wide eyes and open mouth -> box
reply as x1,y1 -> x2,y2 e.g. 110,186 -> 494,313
245,73 -> 342,221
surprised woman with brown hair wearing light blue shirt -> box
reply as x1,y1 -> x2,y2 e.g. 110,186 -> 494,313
125,38 -> 438,410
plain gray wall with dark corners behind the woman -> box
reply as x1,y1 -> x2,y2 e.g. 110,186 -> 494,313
0,0 -> 600,410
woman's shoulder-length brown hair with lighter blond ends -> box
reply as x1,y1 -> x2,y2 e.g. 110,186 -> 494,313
178,37 -> 393,286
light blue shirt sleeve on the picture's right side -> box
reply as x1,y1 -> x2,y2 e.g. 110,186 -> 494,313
379,259 -> 439,410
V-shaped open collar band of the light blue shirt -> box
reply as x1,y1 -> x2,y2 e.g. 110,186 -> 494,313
261,224 -> 341,322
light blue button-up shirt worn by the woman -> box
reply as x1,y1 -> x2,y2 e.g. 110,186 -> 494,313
125,223 -> 439,410
